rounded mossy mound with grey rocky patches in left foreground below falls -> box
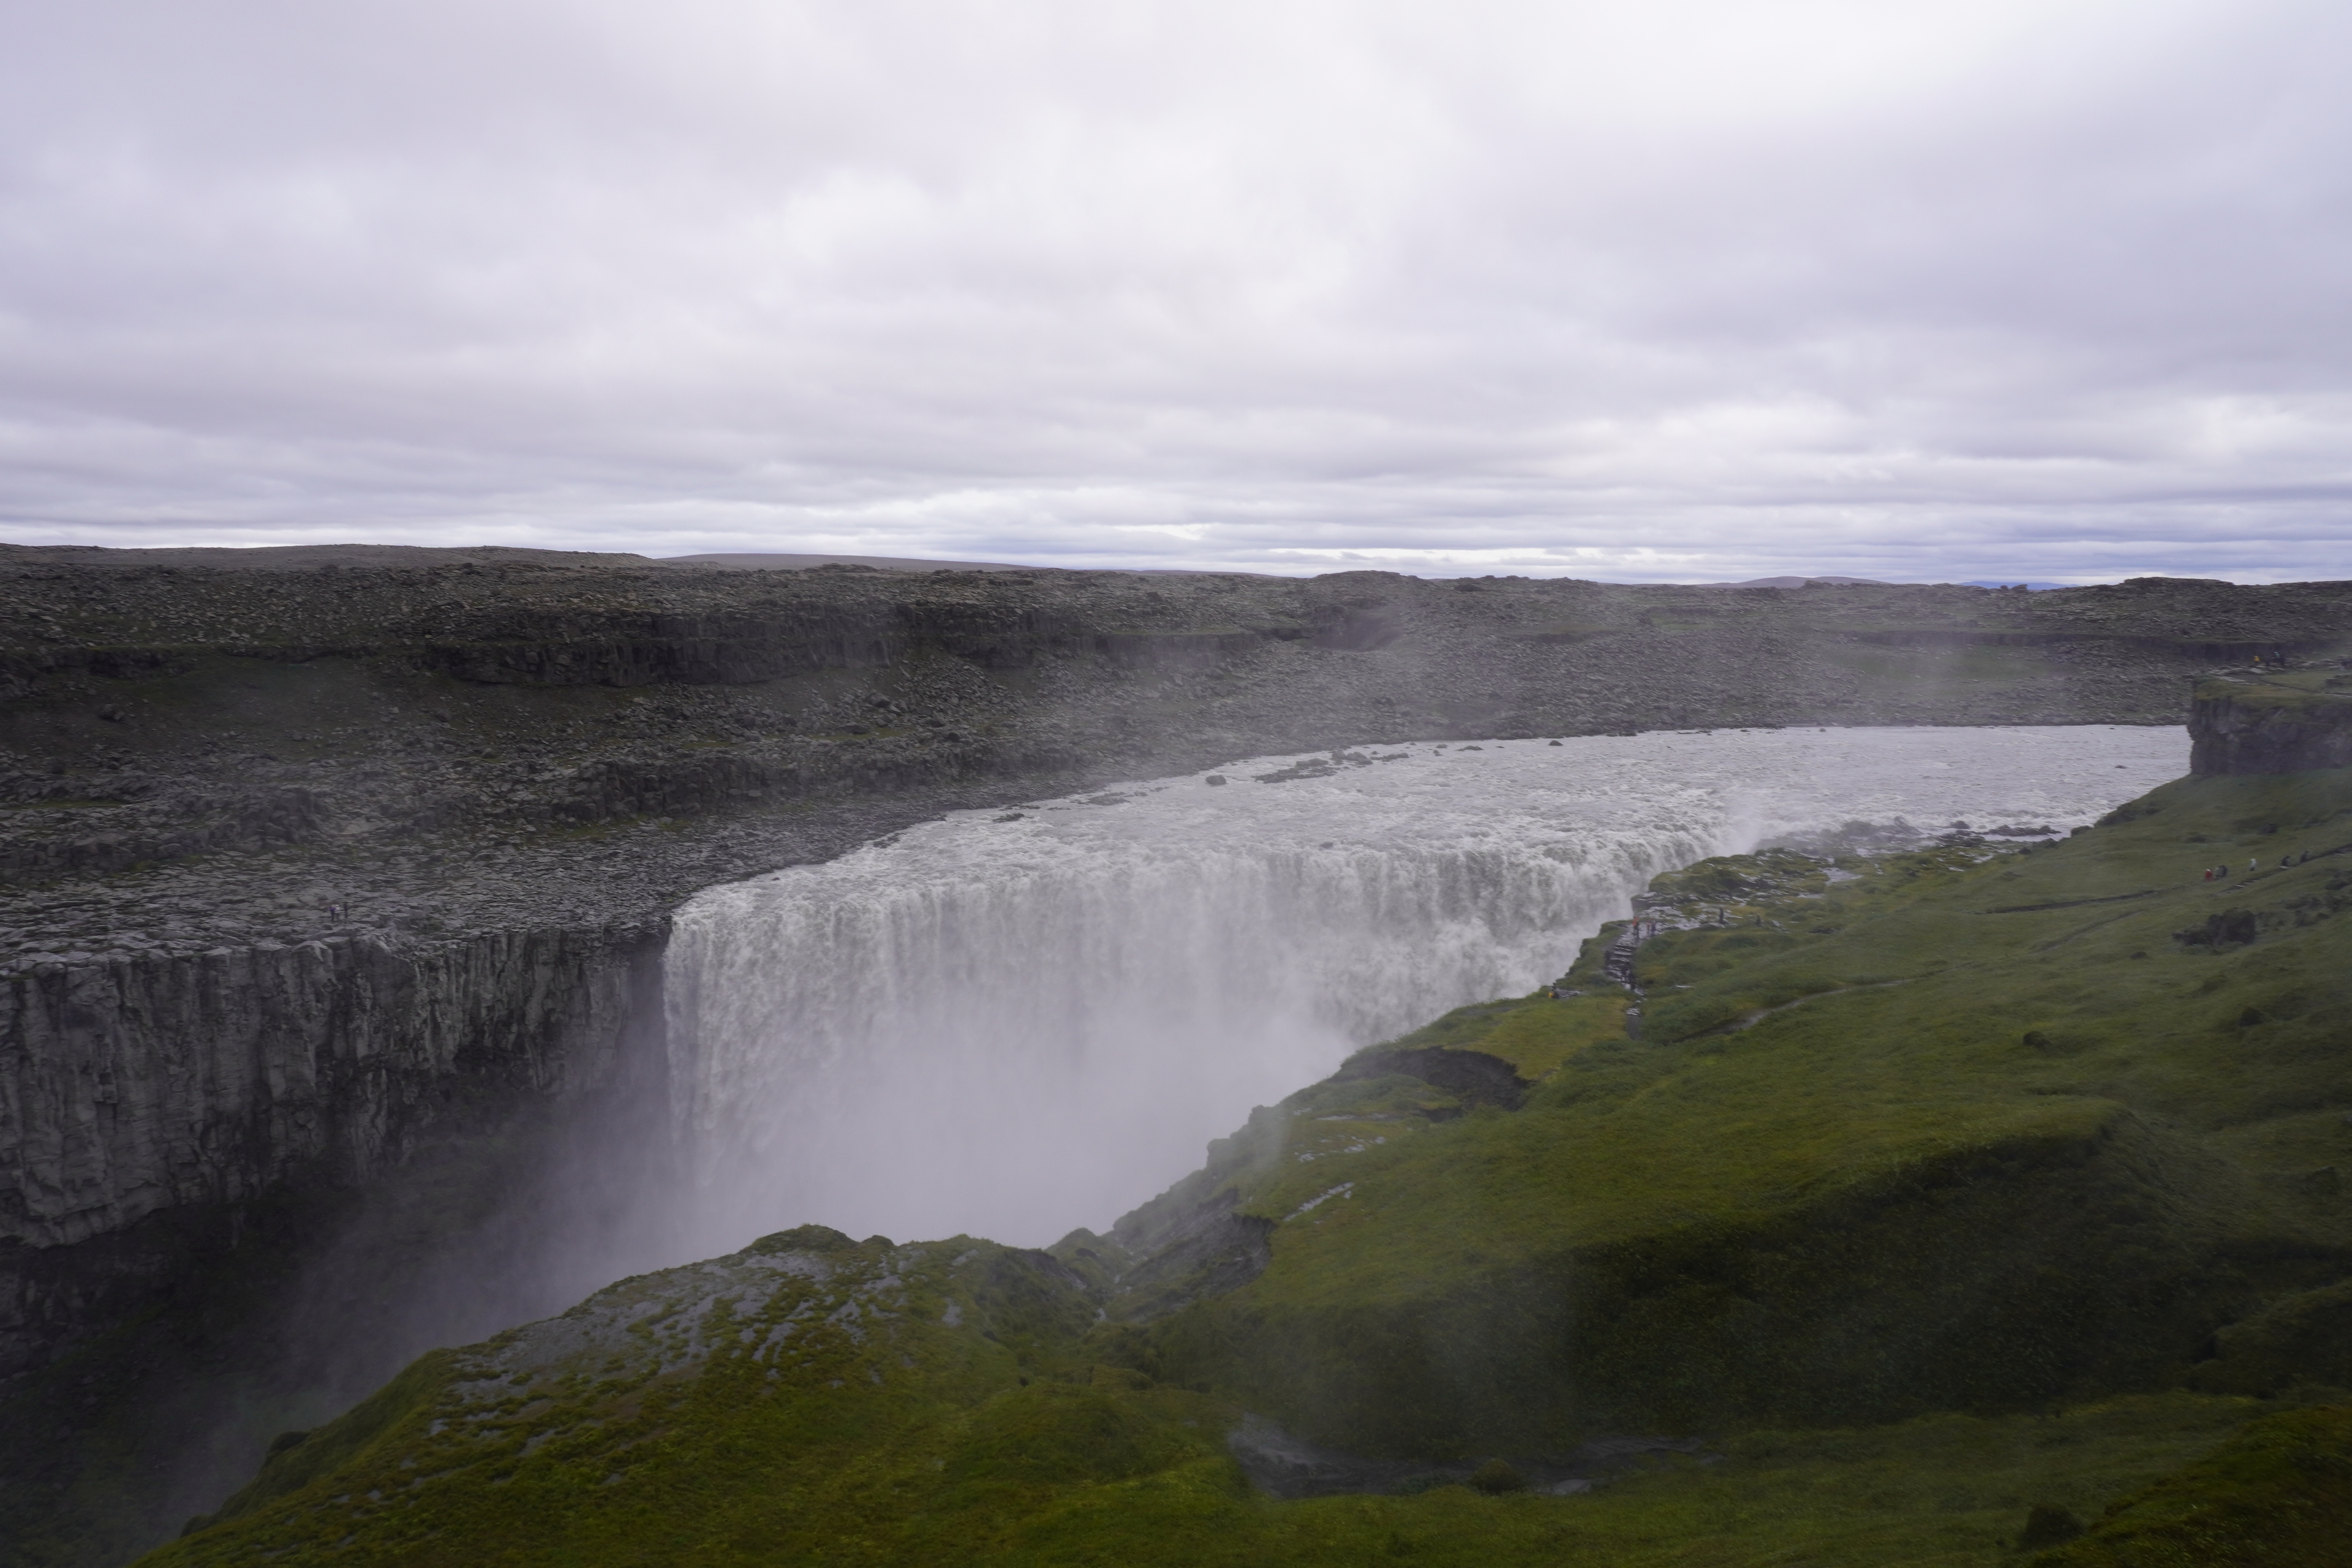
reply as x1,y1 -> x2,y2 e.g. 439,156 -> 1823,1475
151,1227 -> 1176,1563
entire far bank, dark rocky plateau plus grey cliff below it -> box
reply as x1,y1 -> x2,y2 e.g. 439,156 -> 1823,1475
0,548 -> 2352,1561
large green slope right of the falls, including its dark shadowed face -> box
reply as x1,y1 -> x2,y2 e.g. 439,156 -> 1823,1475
1157,774 -> 2352,1453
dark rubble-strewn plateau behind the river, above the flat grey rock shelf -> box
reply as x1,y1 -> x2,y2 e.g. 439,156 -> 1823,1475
0,548 -> 2352,903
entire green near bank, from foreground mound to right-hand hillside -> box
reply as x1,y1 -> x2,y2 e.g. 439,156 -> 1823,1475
133,771 -> 2352,1566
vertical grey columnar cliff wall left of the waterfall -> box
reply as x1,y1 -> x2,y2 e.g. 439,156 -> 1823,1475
0,926 -> 663,1375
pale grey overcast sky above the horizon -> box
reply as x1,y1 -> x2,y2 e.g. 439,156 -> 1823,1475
0,0 -> 2352,581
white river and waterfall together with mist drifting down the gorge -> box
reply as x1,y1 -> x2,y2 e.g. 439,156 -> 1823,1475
119,726 -> 2187,1514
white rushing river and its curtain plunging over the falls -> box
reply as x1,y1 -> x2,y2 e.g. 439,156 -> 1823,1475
668,726 -> 2187,1251
